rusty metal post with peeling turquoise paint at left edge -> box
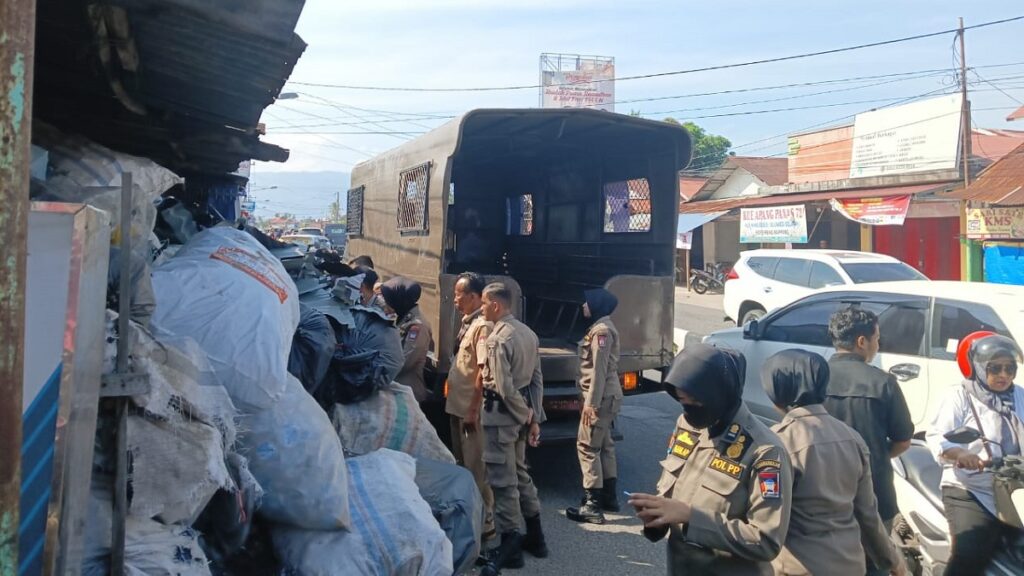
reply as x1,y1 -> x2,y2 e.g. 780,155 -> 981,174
0,0 -> 36,574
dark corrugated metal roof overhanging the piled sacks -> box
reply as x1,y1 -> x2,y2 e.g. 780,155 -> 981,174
34,0 -> 305,174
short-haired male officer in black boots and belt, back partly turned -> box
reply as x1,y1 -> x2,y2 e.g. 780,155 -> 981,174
478,283 -> 548,576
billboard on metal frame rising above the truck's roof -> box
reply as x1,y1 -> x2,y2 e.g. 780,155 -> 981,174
541,54 -> 615,112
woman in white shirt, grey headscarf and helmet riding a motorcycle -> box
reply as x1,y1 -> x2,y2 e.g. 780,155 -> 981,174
928,332 -> 1024,576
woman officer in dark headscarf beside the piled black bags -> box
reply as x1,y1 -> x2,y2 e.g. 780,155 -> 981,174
381,276 -> 433,402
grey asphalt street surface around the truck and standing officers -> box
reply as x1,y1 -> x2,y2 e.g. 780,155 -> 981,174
479,290 -> 734,576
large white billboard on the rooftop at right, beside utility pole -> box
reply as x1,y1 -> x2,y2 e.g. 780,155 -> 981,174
850,94 -> 964,178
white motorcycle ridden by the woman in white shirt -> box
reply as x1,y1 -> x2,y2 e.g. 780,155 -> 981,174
892,427 -> 1024,576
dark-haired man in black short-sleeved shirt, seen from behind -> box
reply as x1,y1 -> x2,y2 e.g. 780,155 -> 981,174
824,304 -> 913,575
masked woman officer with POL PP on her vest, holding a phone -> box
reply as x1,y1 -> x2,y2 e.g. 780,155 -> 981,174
630,343 -> 793,575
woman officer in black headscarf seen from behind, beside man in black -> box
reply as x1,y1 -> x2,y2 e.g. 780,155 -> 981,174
761,349 -> 905,576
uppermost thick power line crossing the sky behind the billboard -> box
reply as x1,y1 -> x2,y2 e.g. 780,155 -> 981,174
289,15 -> 1024,92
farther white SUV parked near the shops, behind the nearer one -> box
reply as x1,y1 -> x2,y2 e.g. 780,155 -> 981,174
722,250 -> 928,326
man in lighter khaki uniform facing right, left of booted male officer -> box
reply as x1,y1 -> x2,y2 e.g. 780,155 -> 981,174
444,273 -> 495,540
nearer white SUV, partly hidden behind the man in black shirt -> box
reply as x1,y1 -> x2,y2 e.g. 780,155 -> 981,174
705,282 -> 1024,431
